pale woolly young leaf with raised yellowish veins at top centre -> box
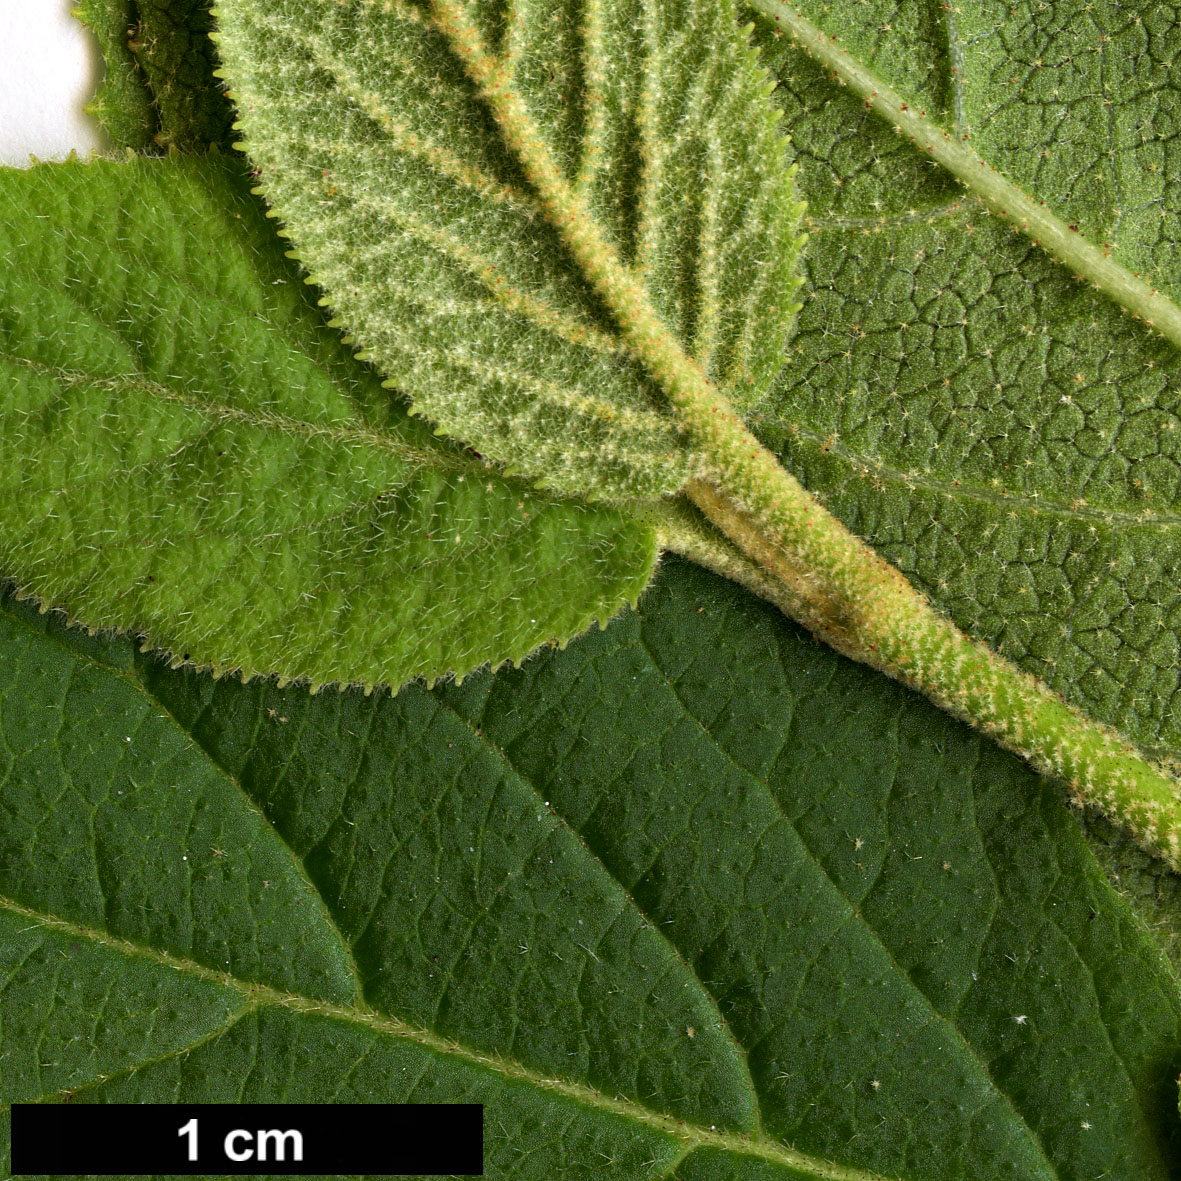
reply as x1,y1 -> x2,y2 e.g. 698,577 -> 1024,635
210,0 -> 801,498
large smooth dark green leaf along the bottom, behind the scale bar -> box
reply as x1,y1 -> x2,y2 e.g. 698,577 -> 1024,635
0,563 -> 1181,1181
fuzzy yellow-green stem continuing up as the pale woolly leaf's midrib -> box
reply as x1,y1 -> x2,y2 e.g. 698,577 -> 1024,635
431,0 -> 1181,868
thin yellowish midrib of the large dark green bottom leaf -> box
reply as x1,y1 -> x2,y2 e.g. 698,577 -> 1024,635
0,895 -> 901,1181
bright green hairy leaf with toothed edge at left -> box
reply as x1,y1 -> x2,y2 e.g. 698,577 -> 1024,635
0,158 -> 655,686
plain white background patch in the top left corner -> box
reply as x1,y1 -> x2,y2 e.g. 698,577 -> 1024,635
0,0 -> 106,167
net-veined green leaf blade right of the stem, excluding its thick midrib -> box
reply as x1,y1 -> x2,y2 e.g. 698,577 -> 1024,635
741,0 -> 1181,757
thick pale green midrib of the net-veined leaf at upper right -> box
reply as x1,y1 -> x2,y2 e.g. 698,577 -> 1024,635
745,0 -> 1181,347
